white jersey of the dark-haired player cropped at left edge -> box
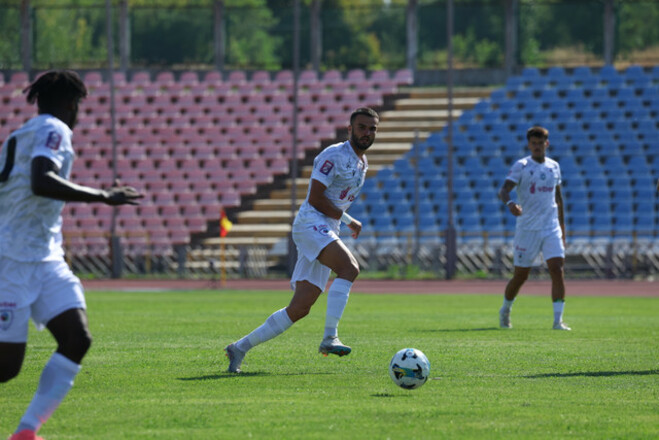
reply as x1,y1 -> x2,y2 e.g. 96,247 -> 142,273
0,114 -> 75,262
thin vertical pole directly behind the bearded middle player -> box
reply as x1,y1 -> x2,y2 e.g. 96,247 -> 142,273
288,0 -> 300,275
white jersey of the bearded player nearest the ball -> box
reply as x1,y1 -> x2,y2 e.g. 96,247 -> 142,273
293,141 -> 368,231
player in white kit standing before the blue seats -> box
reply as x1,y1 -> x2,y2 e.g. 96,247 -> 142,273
499,126 -> 570,330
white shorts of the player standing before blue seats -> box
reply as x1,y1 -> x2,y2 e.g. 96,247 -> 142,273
513,227 -> 565,267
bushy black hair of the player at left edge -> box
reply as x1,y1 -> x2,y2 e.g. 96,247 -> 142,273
23,70 -> 87,111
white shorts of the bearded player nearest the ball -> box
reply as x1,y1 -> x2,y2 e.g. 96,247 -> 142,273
291,220 -> 339,292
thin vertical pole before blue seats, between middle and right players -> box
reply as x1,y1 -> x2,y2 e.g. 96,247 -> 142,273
444,0 -> 457,280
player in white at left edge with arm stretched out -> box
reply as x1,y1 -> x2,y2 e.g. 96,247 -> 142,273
0,70 -> 142,440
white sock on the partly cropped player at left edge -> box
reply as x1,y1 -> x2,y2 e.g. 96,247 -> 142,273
16,353 -> 80,432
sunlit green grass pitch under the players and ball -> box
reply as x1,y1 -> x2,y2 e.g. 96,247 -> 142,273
0,291 -> 659,440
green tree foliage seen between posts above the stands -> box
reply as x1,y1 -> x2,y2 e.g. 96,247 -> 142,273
0,0 -> 659,70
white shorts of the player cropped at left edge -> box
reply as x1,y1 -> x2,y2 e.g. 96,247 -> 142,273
0,257 -> 87,343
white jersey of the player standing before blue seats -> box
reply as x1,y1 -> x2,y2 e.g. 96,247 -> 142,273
506,156 -> 561,231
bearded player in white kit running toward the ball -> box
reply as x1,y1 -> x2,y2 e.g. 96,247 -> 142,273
225,107 -> 379,373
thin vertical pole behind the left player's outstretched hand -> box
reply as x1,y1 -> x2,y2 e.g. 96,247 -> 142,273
105,0 -> 123,278
